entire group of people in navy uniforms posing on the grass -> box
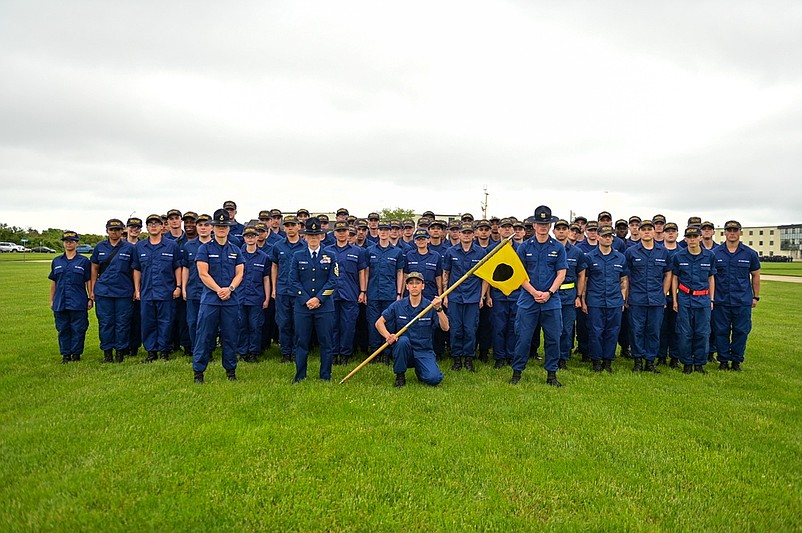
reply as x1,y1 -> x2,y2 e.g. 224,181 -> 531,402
49,201 -> 760,387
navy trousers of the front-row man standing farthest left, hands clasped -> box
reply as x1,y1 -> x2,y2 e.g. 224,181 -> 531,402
192,304 -> 239,372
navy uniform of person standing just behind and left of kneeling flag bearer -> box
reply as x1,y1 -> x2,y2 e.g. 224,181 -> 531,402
367,243 -> 406,352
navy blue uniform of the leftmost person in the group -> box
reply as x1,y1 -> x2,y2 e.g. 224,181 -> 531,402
48,254 -> 92,361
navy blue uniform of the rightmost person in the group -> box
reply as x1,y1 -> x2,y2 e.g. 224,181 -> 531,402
713,243 -> 760,363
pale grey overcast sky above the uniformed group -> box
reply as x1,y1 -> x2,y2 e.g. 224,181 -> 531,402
0,0 -> 802,233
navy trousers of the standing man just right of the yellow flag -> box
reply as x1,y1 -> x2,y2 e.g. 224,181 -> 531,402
512,305 -> 563,372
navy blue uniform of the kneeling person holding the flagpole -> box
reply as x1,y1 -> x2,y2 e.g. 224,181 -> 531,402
382,297 -> 443,385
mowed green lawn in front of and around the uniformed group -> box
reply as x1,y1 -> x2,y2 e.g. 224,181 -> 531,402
0,261 -> 802,531
